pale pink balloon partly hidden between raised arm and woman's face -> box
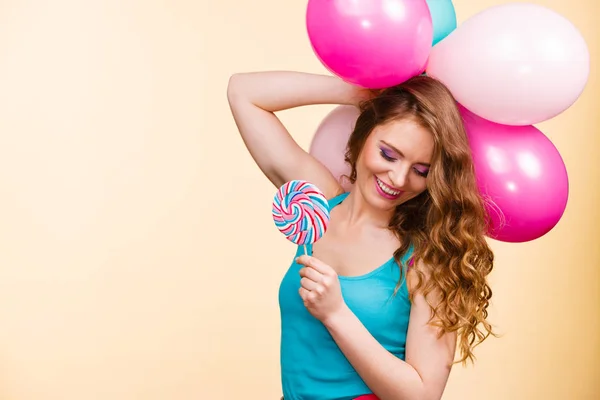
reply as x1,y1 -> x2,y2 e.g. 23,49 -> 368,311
309,105 -> 360,191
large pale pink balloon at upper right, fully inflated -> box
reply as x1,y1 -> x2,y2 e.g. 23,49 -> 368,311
427,3 -> 590,125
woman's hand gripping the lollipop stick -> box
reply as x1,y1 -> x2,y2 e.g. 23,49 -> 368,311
296,255 -> 346,322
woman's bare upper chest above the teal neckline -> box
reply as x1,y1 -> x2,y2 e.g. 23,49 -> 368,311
312,223 -> 400,277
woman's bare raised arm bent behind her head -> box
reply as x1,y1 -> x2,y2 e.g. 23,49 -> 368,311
227,71 -> 368,198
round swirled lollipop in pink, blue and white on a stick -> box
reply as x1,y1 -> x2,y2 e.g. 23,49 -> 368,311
273,180 -> 329,254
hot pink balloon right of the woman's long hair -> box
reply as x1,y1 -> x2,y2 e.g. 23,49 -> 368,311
460,106 -> 569,242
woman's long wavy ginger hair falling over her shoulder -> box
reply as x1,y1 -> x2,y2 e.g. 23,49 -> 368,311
345,75 -> 496,364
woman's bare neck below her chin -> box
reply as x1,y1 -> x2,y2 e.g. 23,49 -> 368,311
341,189 -> 394,229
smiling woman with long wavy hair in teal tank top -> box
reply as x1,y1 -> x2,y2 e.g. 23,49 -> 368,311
228,71 -> 493,400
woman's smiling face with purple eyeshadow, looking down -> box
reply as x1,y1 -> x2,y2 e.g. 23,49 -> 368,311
355,119 -> 434,210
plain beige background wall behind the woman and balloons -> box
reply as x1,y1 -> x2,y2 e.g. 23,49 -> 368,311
0,0 -> 600,400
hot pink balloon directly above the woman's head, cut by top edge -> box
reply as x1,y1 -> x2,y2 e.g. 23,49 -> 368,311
306,0 -> 433,89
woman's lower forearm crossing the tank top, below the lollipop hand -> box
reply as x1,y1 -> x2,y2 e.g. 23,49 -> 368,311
323,307 -> 428,400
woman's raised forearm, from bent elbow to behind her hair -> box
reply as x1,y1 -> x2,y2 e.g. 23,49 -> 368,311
228,71 -> 363,112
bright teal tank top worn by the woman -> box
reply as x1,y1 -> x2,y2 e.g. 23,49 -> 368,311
279,193 -> 412,400
